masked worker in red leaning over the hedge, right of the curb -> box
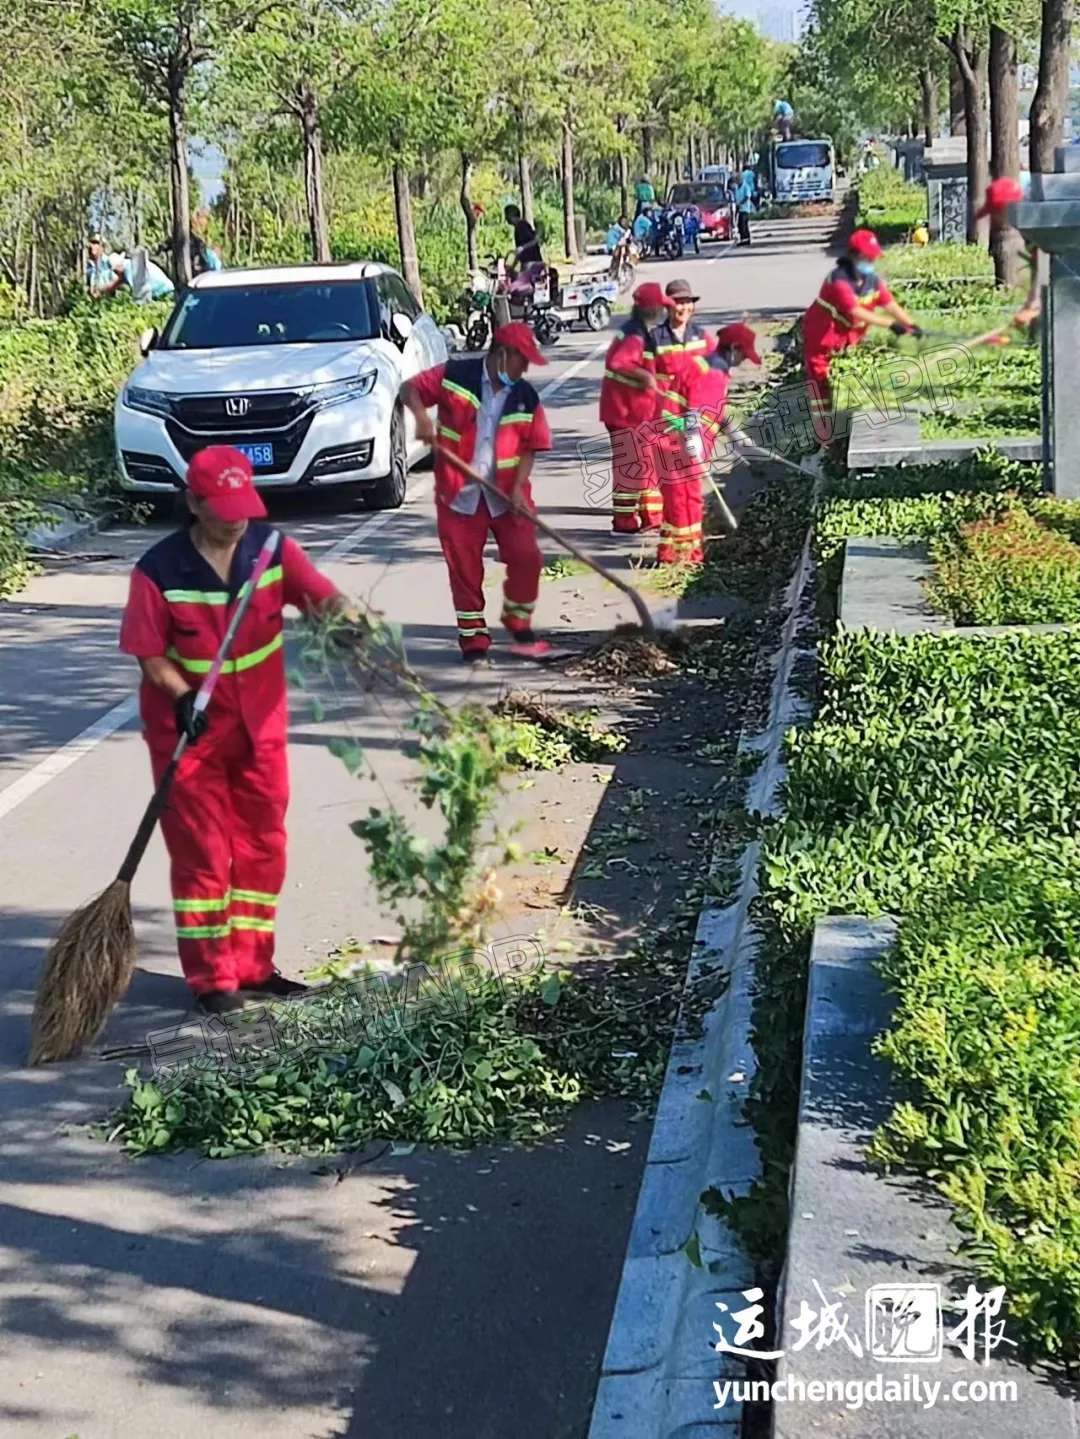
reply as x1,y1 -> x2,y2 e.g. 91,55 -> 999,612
802,230 -> 922,445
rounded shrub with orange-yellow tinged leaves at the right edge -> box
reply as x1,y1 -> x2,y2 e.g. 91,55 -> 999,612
929,505 -> 1080,625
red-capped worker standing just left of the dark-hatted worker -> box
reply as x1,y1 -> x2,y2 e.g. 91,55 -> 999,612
600,282 -> 673,534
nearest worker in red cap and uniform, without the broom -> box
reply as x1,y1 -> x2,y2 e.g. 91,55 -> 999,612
119,445 -> 345,1014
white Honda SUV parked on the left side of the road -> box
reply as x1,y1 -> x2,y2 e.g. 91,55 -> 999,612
115,263 -> 446,509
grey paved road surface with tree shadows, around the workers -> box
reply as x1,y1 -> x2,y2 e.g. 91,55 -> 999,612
0,215 -> 824,1439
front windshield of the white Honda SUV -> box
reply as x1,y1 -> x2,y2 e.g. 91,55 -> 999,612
161,279 -> 378,350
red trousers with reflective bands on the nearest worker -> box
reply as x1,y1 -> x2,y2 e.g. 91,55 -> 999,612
150,725 -> 289,994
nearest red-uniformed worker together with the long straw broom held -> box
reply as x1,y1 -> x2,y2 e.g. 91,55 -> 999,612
30,445 -> 348,1063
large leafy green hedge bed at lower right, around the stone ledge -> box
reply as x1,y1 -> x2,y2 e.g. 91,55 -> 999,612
730,633 -> 1080,1360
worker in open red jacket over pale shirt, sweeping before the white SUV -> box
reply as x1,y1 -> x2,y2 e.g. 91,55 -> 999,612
401,322 -> 551,665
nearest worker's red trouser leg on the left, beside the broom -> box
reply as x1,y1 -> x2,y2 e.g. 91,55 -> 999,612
150,721 -> 237,994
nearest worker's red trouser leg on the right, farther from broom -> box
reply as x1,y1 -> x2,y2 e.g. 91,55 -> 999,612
229,735 -> 289,989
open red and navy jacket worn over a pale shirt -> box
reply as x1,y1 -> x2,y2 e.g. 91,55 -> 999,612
413,358 -> 551,505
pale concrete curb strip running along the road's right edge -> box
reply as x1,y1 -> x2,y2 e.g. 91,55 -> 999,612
588,489 -> 813,1439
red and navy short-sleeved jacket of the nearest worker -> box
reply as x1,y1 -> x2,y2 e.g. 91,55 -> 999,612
119,521 -> 338,747
